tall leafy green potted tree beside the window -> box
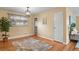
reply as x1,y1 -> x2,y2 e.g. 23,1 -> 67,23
0,17 -> 10,41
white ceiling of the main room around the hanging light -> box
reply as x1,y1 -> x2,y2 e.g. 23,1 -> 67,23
0,7 -> 53,14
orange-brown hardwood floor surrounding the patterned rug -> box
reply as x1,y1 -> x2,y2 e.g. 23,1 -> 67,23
0,36 -> 79,51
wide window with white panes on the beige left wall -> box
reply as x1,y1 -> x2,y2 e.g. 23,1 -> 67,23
9,14 -> 27,26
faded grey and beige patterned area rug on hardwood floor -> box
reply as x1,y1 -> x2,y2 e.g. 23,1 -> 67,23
12,38 -> 53,51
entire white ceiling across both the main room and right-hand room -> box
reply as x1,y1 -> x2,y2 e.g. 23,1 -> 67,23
0,7 -> 79,16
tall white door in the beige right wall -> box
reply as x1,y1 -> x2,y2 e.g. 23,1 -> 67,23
53,12 -> 64,42
